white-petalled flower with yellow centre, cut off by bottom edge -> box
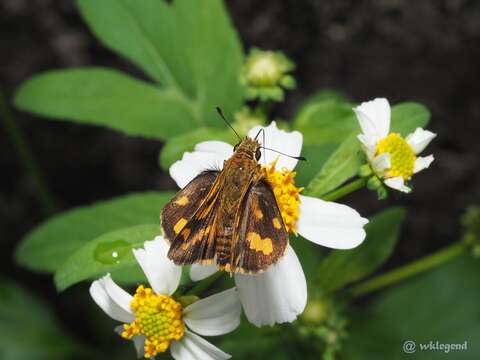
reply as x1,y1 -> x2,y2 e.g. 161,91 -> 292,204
90,236 -> 241,360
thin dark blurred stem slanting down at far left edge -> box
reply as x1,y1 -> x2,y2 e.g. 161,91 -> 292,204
0,90 -> 55,215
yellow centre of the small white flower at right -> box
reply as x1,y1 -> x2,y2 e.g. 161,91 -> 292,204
376,133 -> 416,180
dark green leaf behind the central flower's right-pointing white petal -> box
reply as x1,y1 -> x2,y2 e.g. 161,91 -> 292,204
317,208 -> 405,292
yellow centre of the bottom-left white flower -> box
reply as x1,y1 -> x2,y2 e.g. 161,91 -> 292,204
121,286 -> 185,358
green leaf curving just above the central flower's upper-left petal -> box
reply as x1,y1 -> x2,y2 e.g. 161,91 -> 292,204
160,127 -> 236,170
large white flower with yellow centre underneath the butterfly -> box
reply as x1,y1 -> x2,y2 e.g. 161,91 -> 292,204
170,122 -> 368,326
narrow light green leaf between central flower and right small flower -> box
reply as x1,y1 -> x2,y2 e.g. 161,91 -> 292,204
305,135 -> 364,197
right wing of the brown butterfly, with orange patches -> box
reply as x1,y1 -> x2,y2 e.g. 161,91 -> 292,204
231,181 -> 288,273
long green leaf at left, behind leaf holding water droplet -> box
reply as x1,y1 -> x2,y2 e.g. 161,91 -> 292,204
16,192 -> 174,272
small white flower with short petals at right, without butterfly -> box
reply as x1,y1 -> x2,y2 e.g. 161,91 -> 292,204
353,99 -> 437,193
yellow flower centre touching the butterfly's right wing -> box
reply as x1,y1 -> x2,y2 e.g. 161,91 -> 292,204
263,158 -> 303,235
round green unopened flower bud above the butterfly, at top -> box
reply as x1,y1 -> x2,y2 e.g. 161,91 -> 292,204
240,48 -> 296,101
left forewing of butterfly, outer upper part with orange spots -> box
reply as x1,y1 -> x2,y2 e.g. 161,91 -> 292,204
160,171 -> 218,244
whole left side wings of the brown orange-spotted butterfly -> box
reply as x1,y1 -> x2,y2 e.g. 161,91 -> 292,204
161,171 -> 221,265
